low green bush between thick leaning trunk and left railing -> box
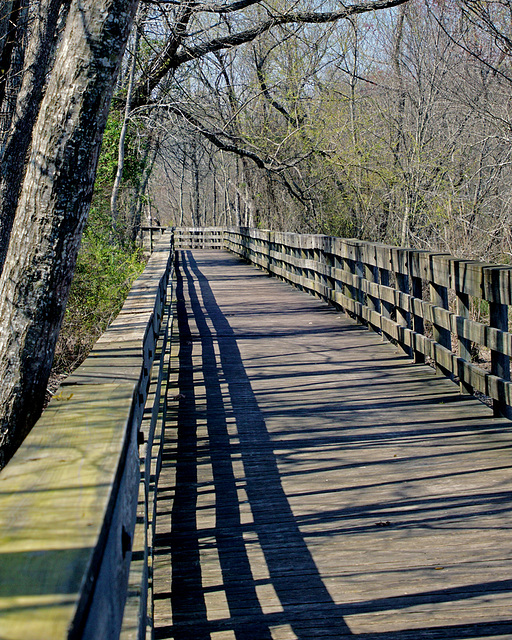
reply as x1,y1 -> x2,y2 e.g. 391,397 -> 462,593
54,209 -> 145,374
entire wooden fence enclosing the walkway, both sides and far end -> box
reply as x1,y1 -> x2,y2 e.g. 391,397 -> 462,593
0,227 -> 512,640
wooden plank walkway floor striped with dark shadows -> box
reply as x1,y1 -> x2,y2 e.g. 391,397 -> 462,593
154,251 -> 512,640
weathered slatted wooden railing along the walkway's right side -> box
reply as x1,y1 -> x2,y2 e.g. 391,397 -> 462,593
225,227 -> 512,417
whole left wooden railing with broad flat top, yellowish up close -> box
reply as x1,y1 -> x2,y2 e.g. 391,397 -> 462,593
0,231 -> 173,640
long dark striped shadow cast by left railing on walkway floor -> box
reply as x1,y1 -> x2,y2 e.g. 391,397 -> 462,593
157,254 -> 350,640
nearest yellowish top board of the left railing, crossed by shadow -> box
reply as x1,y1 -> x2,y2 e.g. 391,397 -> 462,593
0,382 -> 135,640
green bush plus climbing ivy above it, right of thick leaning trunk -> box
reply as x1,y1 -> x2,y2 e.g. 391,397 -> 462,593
53,101 -> 152,374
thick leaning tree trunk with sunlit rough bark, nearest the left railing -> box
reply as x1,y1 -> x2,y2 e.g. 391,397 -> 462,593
0,0 -> 137,466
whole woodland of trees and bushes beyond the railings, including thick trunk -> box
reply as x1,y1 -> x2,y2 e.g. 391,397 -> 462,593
0,0 -> 512,468
